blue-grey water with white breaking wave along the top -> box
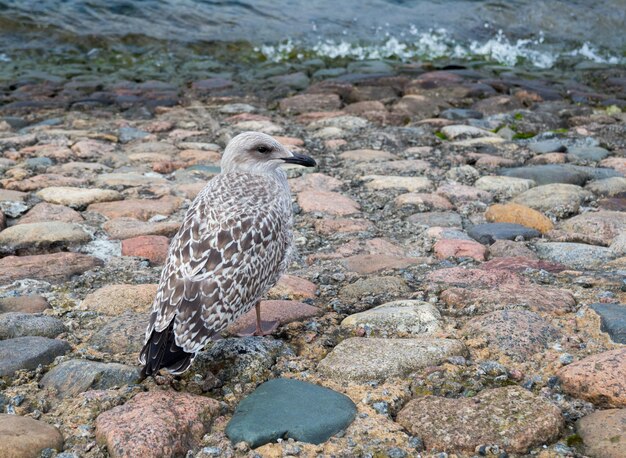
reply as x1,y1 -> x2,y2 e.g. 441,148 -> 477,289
0,0 -> 626,81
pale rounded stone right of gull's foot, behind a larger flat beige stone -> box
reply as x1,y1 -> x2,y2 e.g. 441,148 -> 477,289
341,300 -> 441,337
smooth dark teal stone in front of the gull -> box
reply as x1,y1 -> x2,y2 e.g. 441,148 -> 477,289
226,378 -> 356,448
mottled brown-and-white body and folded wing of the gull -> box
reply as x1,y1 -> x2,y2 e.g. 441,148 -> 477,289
146,175 -> 291,353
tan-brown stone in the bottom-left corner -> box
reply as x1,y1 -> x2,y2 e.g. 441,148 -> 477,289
0,413 -> 63,458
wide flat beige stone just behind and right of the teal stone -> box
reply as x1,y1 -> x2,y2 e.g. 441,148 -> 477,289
317,337 -> 467,382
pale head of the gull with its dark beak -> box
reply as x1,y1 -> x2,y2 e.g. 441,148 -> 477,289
221,132 -> 316,173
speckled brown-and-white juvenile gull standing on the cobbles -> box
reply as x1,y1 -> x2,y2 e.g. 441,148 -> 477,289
139,132 -> 315,375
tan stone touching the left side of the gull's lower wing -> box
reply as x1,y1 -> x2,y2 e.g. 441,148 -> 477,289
78,283 -> 157,316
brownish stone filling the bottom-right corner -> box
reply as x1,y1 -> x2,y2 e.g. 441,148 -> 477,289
576,409 -> 626,458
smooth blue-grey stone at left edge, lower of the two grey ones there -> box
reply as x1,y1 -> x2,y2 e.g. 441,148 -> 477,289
0,336 -> 71,377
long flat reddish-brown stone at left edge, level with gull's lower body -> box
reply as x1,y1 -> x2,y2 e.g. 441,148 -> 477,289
0,253 -> 103,283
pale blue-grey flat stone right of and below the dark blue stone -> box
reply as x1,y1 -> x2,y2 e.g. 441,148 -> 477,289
535,242 -> 614,269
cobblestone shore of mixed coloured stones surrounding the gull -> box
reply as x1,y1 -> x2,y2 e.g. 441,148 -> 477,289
0,61 -> 626,458
